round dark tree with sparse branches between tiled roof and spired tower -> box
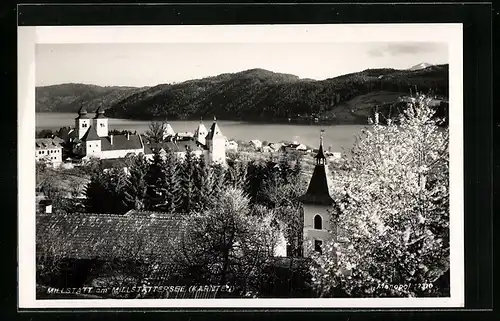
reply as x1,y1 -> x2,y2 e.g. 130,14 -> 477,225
177,188 -> 278,293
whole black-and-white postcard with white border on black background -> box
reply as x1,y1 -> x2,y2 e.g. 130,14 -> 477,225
19,24 -> 464,308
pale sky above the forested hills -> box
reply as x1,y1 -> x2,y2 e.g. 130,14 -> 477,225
35,42 -> 449,87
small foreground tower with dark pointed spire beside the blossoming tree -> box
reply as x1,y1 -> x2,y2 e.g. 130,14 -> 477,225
300,130 -> 336,256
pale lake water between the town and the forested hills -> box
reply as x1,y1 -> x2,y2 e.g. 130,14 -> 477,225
36,113 -> 365,152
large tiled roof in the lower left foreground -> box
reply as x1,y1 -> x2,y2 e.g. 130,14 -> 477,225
36,213 -> 182,259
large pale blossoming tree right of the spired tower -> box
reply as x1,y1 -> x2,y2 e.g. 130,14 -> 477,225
311,95 -> 449,297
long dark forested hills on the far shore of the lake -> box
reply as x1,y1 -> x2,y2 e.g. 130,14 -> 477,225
37,65 -> 448,123
